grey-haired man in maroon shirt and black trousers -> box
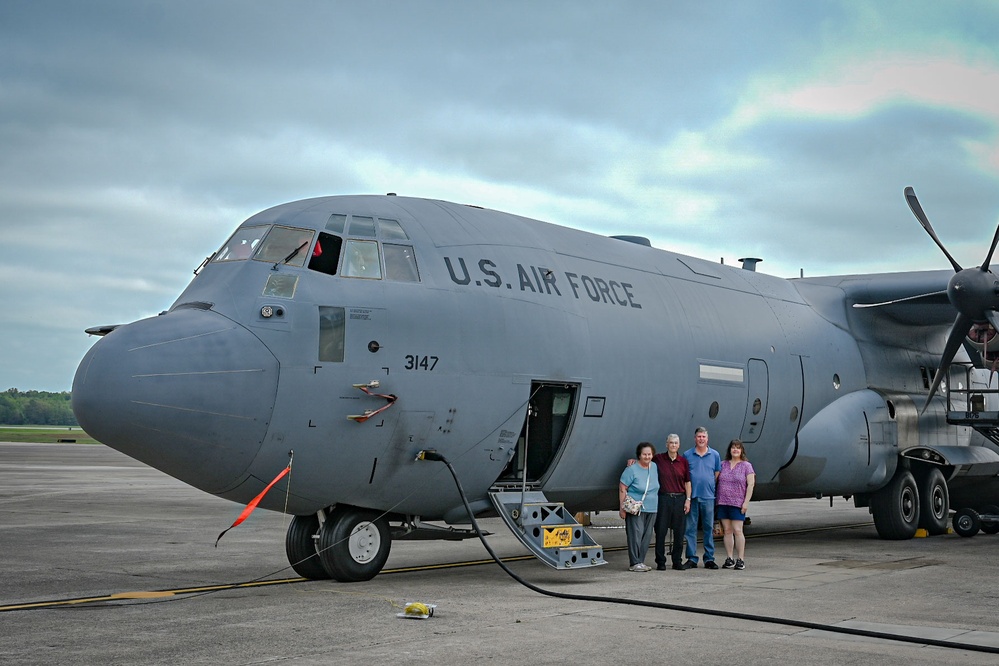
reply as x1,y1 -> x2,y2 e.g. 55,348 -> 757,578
652,434 -> 690,571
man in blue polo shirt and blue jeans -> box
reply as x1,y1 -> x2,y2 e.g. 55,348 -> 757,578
683,427 -> 721,569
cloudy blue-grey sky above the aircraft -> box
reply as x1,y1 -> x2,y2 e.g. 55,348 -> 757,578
0,0 -> 999,391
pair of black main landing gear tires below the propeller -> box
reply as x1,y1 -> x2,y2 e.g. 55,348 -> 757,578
870,466 -> 956,540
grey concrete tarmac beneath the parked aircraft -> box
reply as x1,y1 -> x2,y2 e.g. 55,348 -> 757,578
0,443 -> 999,666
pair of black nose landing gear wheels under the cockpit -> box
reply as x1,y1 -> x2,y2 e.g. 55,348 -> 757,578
285,505 -> 392,583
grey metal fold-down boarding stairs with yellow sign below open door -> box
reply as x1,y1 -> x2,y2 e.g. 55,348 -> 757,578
489,490 -> 607,570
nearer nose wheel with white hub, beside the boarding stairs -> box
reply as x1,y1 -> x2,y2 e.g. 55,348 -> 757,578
319,506 -> 392,583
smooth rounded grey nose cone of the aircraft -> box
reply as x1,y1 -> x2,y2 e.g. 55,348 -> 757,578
73,308 -> 279,493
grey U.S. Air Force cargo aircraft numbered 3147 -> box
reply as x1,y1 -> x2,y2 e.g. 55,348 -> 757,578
73,189 -> 999,581
